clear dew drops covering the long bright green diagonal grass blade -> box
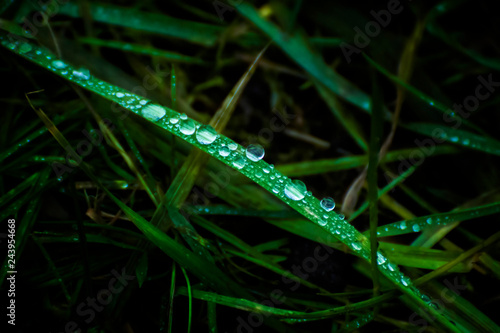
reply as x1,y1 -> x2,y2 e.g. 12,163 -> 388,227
0,36 -> 440,302
